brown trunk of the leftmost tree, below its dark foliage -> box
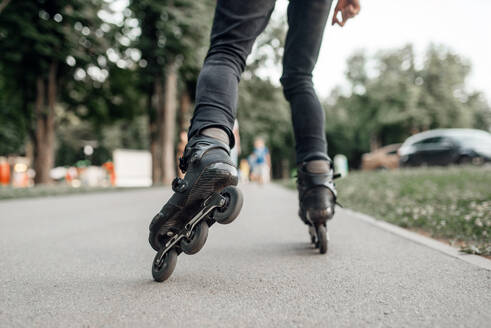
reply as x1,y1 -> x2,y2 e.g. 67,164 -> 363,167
34,63 -> 57,184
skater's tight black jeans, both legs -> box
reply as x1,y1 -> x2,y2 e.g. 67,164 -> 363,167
189,0 -> 332,163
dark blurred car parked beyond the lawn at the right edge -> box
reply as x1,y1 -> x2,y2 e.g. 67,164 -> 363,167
399,129 -> 491,166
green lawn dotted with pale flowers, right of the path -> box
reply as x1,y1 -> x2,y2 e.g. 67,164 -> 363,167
282,167 -> 491,256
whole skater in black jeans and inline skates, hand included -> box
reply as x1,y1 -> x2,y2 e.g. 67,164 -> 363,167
149,0 -> 360,281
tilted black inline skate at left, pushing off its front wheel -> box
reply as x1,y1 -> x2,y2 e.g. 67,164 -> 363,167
149,135 -> 243,282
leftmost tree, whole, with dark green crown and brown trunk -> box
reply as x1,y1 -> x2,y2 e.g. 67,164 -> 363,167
0,0 -> 108,183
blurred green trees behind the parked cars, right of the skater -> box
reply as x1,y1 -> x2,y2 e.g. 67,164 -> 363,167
326,45 -> 491,166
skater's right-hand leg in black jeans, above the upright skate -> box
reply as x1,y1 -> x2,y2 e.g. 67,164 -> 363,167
281,0 -> 332,163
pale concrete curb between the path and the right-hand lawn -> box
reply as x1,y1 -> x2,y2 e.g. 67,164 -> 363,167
343,208 -> 491,271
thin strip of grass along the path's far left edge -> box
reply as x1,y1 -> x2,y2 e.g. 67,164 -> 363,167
0,185 -> 142,200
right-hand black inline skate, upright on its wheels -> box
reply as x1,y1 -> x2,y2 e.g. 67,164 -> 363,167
297,160 -> 336,254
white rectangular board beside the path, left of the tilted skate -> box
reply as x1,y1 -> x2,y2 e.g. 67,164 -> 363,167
113,149 -> 152,187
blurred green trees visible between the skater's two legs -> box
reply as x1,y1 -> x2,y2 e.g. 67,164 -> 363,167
238,14 -> 295,178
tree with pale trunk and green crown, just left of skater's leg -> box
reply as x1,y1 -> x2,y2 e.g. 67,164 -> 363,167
129,0 -> 211,183
